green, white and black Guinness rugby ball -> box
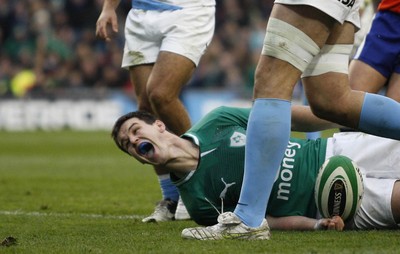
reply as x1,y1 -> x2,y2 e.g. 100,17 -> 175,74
315,155 -> 364,222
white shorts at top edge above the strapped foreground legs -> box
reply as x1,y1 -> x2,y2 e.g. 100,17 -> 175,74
275,0 -> 361,28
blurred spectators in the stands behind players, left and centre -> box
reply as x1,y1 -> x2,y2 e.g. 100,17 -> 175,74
0,0 -> 282,99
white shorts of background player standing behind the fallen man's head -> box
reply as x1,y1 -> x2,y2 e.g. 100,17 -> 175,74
122,6 -> 215,68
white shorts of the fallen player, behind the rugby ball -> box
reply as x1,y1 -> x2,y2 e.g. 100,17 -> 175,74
326,132 -> 400,229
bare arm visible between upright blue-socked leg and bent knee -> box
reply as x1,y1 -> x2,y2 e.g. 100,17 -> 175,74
292,105 -> 342,132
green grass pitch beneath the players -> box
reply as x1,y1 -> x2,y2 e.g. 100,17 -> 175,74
0,131 -> 400,254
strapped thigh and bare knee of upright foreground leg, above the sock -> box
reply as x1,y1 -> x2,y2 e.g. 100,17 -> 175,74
254,2 -> 335,100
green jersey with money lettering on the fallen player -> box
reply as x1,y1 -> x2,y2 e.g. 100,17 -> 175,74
171,107 -> 326,225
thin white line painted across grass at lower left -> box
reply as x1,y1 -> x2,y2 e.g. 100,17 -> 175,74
0,211 -> 144,220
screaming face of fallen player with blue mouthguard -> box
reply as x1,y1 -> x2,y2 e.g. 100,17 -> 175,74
118,118 -> 165,165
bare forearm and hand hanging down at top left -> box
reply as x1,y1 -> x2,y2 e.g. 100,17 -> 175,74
96,0 -> 120,41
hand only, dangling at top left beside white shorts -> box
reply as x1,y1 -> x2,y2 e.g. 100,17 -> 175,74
96,10 -> 118,41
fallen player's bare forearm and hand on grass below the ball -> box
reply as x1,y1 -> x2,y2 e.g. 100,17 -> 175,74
267,216 -> 344,231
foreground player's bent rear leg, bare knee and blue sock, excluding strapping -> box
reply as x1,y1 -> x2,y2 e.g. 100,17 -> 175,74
303,22 -> 400,139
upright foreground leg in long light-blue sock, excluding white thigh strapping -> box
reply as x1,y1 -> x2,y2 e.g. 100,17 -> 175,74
234,4 -> 335,227
